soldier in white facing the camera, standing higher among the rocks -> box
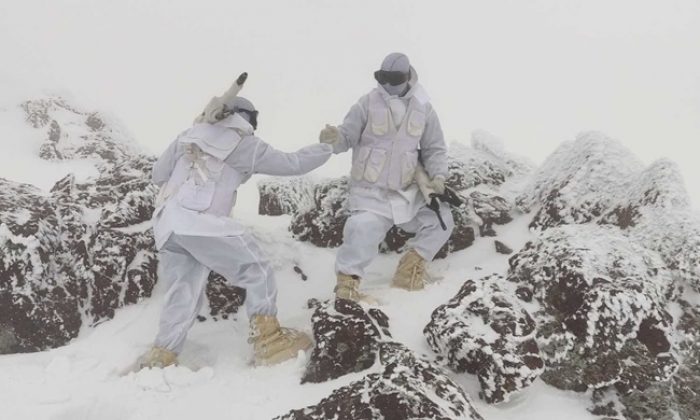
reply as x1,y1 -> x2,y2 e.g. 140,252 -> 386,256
319,53 -> 454,301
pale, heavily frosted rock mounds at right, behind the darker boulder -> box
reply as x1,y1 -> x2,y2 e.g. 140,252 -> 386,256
516,132 -> 700,291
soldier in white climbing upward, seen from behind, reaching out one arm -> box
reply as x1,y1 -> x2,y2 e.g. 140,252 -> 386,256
139,87 -> 332,368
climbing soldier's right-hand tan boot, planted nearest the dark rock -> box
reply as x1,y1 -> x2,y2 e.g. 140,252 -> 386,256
248,315 -> 313,366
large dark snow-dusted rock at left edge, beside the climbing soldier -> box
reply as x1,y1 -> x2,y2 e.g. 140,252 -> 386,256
0,169 -> 156,353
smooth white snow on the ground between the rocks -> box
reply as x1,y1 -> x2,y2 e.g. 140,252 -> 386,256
0,180 -> 592,420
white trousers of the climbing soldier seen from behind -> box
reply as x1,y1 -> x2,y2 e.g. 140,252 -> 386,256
155,233 -> 277,353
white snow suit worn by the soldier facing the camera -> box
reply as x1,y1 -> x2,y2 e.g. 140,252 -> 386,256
333,60 -> 454,278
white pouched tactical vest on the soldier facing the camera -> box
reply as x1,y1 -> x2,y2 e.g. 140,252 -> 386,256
350,89 -> 426,190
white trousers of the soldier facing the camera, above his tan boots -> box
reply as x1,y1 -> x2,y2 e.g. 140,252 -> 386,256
335,203 -> 454,278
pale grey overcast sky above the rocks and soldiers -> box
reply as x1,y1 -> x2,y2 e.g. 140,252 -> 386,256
0,0 -> 700,203
